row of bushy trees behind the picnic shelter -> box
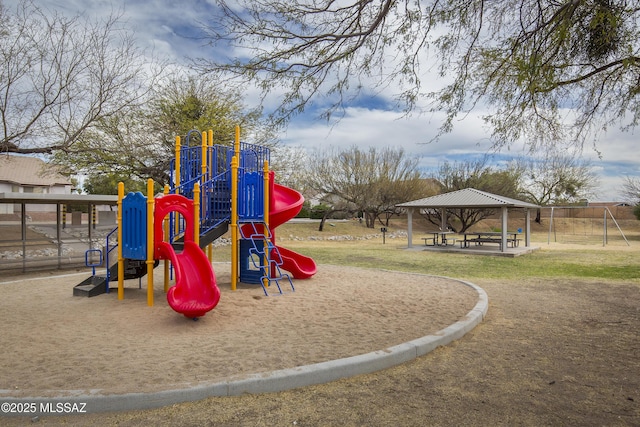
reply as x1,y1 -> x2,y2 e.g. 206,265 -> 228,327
302,146 -> 598,232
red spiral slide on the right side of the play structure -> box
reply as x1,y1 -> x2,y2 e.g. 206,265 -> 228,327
269,179 -> 318,279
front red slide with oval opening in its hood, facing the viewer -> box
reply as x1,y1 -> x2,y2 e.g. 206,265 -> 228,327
154,194 -> 220,318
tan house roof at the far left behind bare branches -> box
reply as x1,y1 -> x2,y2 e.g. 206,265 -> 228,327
0,154 -> 71,186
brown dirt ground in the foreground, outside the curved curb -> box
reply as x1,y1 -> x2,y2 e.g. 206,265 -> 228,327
1,279 -> 640,426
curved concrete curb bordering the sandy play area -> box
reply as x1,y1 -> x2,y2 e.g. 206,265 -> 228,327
0,273 -> 489,416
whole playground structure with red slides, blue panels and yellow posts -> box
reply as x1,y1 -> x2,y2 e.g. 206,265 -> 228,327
74,127 -> 317,318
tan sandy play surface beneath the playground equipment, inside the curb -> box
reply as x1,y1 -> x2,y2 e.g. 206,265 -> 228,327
0,263 -> 477,397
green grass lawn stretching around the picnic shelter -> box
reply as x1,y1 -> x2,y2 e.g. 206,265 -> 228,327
214,217 -> 640,280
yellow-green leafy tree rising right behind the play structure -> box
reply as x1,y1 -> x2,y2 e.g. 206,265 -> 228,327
56,74 -> 274,185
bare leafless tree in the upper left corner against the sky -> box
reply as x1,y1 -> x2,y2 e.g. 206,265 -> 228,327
0,0 -> 157,154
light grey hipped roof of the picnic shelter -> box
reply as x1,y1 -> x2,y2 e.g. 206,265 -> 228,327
396,188 -> 538,208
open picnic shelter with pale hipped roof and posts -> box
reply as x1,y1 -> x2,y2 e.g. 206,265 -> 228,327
396,188 -> 539,252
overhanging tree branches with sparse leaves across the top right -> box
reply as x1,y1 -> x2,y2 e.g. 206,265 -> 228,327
198,0 -> 640,149
